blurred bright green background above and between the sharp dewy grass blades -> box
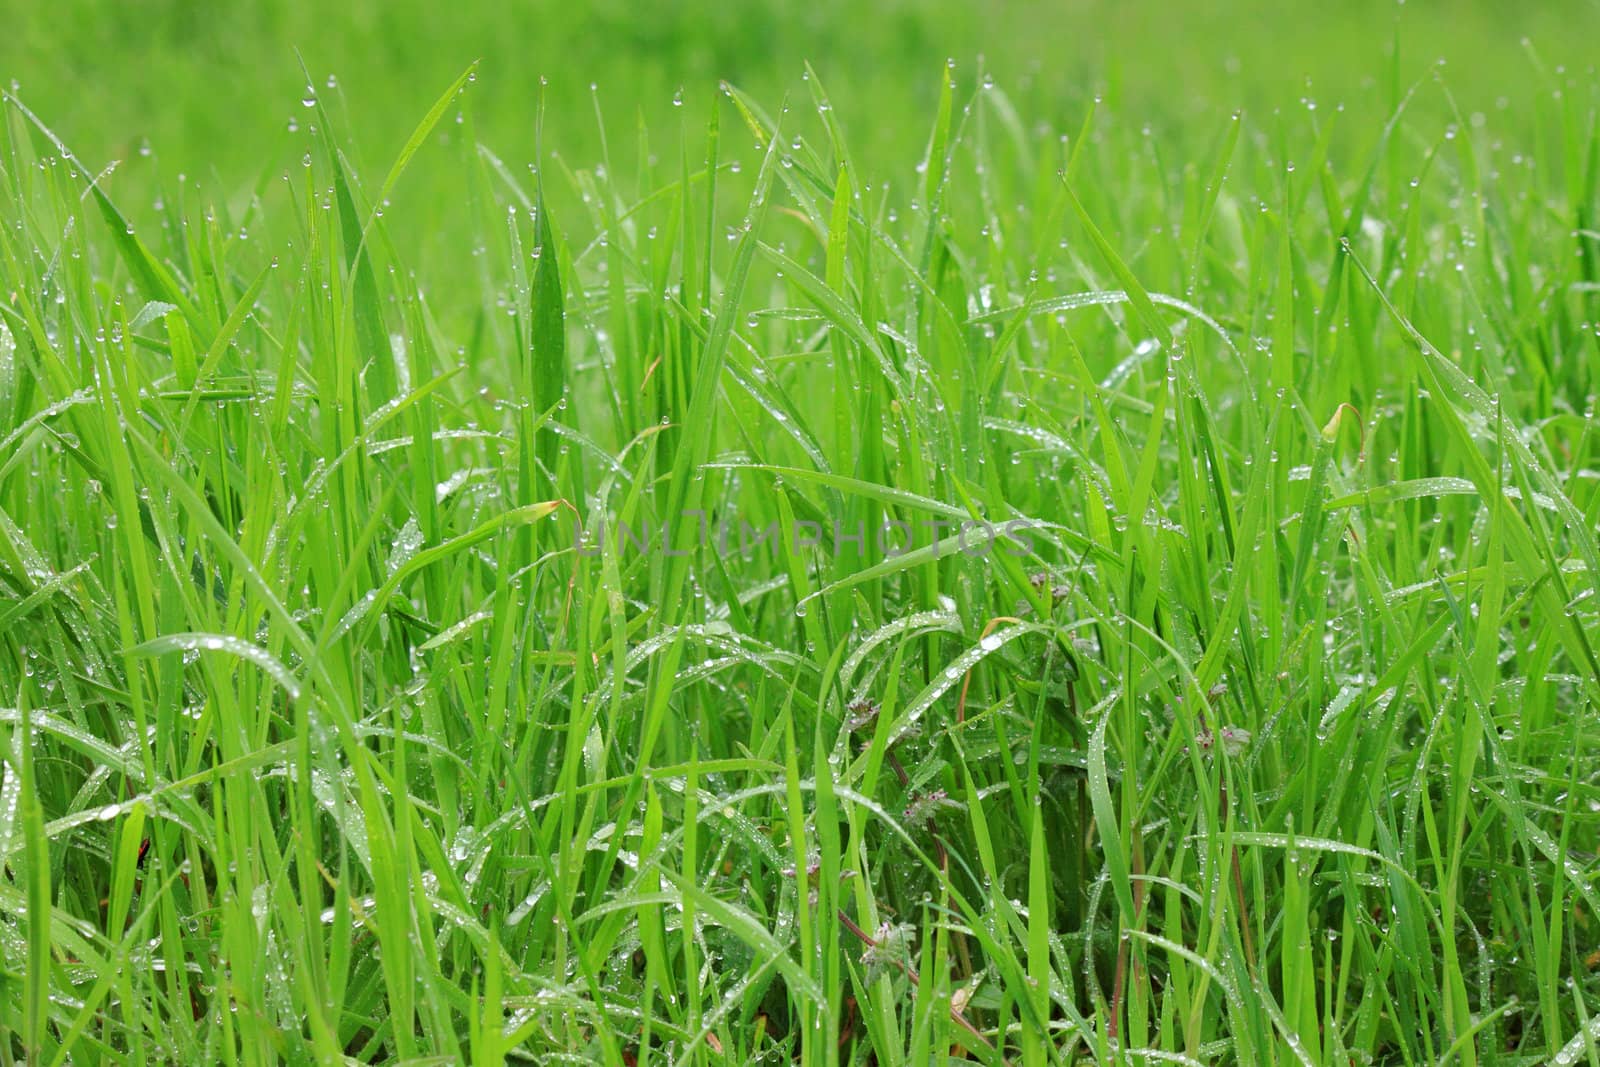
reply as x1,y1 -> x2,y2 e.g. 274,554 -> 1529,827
0,0 -> 1600,342
